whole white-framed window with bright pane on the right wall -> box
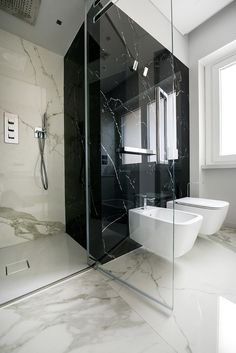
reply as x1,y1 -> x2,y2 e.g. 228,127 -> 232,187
205,55 -> 236,164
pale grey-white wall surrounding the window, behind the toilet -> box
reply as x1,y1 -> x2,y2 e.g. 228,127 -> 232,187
189,1 -> 236,227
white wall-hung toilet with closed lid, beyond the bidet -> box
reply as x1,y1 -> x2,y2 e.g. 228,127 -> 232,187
167,197 -> 229,235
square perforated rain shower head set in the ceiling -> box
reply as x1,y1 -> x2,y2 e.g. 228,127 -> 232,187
0,0 -> 41,25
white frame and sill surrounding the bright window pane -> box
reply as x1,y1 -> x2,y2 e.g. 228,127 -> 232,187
205,50 -> 236,166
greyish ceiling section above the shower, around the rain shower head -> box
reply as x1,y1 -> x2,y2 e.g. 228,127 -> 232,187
0,0 -> 84,55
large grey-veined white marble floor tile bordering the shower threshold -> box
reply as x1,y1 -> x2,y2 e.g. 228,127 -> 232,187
0,270 -> 175,353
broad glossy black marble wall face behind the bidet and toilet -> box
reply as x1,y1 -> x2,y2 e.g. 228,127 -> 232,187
87,5 -> 189,258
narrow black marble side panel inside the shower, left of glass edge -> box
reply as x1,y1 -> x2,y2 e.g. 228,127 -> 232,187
64,27 -> 86,247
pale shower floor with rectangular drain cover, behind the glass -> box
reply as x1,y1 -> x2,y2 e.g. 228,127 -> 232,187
0,233 -> 87,305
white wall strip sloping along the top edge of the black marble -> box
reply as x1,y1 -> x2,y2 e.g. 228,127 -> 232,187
116,0 -> 188,66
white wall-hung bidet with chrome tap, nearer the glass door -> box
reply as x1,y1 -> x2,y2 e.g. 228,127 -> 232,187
129,206 -> 202,260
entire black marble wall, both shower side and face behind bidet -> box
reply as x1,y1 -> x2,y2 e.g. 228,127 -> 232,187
65,5 -> 189,261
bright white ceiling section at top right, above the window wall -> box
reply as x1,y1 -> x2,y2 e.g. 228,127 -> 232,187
150,0 -> 233,34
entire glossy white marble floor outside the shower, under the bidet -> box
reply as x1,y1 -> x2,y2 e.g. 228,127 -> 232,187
0,229 -> 236,353
